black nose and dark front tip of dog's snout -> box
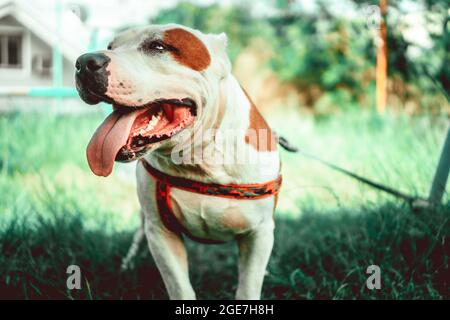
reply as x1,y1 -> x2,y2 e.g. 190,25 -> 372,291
75,53 -> 111,104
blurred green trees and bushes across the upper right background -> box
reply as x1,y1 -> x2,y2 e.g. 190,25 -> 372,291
152,0 -> 450,113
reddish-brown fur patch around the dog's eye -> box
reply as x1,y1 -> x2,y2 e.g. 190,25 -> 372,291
163,28 -> 211,71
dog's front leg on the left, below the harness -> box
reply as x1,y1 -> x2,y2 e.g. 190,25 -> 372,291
145,219 -> 195,300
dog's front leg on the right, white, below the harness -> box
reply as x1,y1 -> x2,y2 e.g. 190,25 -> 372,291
236,221 -> 274,300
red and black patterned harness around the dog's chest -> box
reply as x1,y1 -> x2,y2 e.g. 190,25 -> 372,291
141,159 -> 281,243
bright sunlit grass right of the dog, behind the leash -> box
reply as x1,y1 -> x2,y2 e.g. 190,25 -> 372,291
270,112 -> 450,217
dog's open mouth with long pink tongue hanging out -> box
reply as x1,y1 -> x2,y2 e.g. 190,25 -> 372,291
86,98 -> 197,177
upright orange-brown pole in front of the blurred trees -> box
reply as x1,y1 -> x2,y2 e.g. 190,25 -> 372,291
376,0 -> 388,114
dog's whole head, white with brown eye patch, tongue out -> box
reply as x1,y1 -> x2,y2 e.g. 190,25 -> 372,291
75,24 -> 230,176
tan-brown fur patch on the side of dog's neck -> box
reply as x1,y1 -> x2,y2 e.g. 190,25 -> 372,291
242,88 -> 277,151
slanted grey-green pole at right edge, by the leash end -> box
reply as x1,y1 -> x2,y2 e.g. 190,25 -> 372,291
429,127 -> 450,204
